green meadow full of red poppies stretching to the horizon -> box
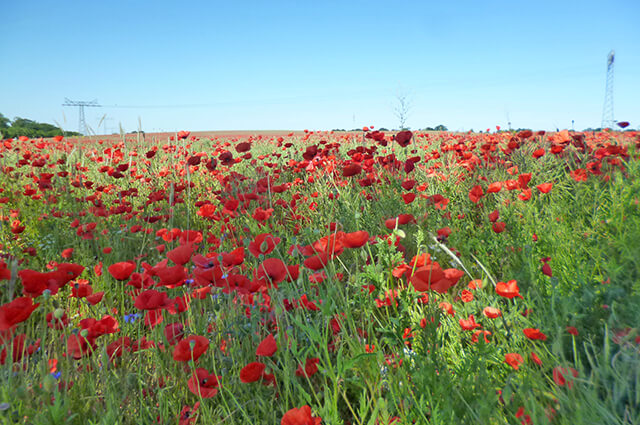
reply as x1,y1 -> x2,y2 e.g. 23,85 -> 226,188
0,126 -> 640,425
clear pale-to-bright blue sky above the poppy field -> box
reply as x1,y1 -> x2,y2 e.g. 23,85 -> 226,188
0,0 -> 640,133
